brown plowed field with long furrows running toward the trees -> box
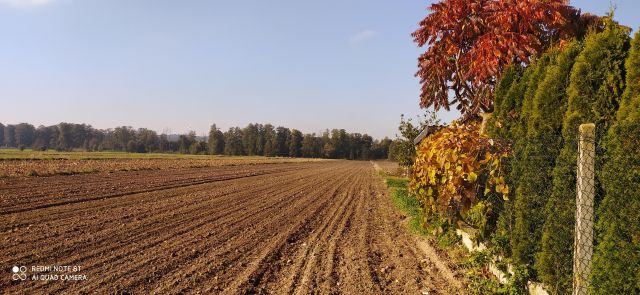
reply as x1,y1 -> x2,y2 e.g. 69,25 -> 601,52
0,161 -> 460,294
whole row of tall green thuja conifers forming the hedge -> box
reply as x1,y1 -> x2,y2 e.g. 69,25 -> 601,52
488,19 -> 640,294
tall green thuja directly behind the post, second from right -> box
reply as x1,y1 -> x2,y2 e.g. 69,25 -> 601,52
536,20 -> 629,294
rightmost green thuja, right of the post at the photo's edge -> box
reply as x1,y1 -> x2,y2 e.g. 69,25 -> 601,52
590,33 -> 640,294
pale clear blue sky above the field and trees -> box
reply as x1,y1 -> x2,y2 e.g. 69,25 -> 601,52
0,0 -> 640,138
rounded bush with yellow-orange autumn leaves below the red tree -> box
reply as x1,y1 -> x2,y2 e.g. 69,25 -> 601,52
411,122 -> 510,232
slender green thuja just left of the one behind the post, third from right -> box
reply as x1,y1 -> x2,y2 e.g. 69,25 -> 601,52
513,41 -> 581,274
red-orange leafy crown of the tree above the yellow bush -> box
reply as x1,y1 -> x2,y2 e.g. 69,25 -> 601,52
412,0 -> 598,116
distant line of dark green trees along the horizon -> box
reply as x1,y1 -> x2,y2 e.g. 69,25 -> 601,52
0,123 -> 394,160
